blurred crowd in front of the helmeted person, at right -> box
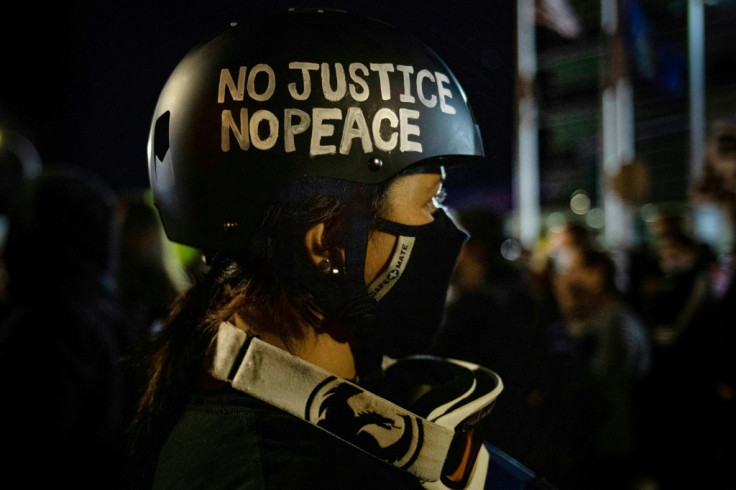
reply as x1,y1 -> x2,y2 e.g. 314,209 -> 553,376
436,205 -> 736,489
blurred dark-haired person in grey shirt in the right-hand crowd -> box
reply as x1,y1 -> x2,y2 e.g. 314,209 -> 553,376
552,245 -> 652,489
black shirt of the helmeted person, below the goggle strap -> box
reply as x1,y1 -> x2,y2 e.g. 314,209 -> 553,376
153,388 -> 421,490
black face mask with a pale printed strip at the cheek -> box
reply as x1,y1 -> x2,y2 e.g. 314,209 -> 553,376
368,209 -> 467,358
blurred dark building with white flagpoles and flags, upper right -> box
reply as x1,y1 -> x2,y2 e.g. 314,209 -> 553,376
514,0 -> 736,256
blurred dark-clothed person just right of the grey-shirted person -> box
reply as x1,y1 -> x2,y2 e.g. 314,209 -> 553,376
640,224 -> 715,489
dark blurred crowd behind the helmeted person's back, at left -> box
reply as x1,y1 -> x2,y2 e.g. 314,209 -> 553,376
0,161 -> 180,489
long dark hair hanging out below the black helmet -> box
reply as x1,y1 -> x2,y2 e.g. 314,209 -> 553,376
131,179 -> 392,478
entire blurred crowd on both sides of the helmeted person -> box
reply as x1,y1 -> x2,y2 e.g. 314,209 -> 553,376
0,127 -> 736,490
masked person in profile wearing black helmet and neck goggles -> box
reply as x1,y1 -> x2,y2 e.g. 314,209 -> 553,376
129,10 -> 502,488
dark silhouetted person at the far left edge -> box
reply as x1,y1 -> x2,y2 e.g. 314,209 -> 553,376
0,166 -> 124,488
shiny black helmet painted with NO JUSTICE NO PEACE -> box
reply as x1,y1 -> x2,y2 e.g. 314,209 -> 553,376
148,9 -> 483,250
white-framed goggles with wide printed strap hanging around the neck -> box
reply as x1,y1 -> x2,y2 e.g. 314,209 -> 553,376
209,322 -> 503,489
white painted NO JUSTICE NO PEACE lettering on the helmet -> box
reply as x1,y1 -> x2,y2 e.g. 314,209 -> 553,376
217,61 -> 456,156
